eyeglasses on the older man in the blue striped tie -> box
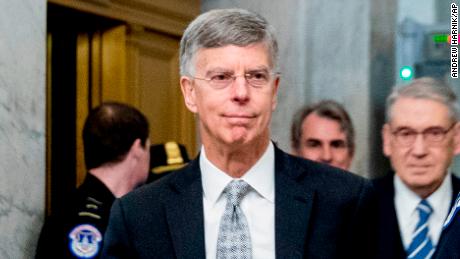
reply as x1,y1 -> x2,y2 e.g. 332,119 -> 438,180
392,123 -> 456,146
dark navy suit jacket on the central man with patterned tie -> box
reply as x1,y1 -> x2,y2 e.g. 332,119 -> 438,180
103,148 -> 376,259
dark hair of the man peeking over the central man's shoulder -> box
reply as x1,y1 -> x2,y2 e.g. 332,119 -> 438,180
291,100 -> 355,155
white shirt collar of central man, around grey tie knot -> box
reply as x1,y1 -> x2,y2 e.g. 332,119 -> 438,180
200,142 -> 275,204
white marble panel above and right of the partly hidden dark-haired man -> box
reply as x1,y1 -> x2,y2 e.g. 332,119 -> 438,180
307,0 -> 371,175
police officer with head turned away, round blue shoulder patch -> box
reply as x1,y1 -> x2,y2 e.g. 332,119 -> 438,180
36,102 -> 150,258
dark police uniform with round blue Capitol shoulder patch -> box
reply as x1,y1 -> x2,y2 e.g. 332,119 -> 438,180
36,173 -> 115,258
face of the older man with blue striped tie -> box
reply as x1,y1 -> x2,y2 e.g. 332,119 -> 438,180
383,98 -> 459,195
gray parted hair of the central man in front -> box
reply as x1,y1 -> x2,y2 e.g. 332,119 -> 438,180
180,9 -> 278,75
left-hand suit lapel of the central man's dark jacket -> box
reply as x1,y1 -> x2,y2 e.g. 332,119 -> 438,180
165,159 -> 206,258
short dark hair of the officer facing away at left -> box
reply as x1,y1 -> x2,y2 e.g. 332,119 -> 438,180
83,102 -> 149,170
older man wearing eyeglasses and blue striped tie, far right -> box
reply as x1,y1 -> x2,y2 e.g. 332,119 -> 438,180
374,78 -> 460,259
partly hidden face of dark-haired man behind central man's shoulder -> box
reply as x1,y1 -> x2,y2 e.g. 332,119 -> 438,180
297,112 -> 353,170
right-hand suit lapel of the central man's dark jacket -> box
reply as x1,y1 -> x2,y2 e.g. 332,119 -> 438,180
275,148 -> 315,259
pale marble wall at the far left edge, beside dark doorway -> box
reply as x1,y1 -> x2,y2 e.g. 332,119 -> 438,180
0,0 -> 46,259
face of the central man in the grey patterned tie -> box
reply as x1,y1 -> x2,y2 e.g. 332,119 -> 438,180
181,43 -> 279,149
